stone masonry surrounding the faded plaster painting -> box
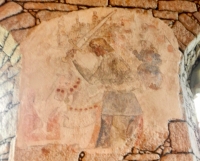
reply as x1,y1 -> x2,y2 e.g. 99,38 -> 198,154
0,0 -> 200,161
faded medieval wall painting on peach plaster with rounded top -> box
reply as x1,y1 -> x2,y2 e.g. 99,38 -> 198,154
16,8 -> 182,160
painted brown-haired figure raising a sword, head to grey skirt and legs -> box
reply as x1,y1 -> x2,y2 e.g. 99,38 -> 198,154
73,38 -> 142,148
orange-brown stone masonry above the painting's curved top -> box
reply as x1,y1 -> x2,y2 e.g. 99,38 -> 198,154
0,0 -> 200,51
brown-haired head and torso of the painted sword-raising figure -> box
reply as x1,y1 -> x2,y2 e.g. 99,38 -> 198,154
73,38 -> 131,85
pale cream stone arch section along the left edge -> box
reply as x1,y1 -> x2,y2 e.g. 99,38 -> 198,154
0,27 -> 21,160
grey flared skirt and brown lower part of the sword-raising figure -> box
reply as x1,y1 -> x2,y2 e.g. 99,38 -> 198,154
96,91 -> 142,148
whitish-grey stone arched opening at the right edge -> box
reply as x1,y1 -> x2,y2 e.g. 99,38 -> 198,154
179,39 -> 200,155
